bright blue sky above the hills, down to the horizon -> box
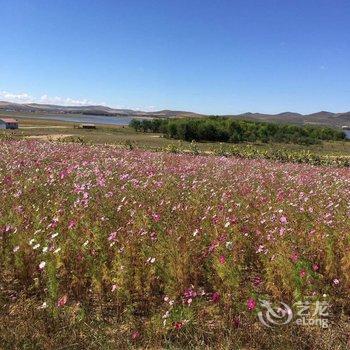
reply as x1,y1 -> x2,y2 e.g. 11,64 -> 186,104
0,0 -> 350,114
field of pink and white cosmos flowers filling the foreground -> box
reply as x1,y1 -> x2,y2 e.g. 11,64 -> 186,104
0,141 -> 350,349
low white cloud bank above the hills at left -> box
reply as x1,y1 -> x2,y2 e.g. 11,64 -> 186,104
0,91 -> 105,106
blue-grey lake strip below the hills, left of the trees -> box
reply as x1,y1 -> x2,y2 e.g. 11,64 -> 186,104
16,114 -> 139,125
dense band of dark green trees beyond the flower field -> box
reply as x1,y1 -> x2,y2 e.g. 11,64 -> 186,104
130,116 -> 345,144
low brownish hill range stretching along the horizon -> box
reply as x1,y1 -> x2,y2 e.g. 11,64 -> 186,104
0,101 -> 350,127
